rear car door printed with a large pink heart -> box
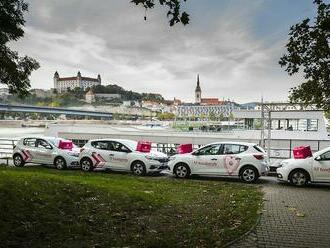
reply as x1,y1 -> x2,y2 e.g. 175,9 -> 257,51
219,143 -> 248,176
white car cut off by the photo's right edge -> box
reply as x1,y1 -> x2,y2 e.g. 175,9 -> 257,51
276,147 -> 330,186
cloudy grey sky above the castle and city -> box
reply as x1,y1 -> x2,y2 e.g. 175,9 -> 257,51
12,0 -> 315,103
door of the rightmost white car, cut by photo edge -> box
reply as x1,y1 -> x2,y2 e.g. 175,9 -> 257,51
313,151 -> 330,182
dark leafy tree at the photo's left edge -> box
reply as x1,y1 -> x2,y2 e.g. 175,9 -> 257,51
0,0 -> 39,97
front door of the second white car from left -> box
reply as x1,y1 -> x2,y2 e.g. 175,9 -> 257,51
109,141 -> 131,170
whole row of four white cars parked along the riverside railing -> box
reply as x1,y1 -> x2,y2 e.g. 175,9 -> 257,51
13,137 -> 330,186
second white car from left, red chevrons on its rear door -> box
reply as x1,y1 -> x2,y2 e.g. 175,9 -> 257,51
80,139 -> 168,175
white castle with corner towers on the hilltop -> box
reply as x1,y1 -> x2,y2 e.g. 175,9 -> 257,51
54,71 -> 101,93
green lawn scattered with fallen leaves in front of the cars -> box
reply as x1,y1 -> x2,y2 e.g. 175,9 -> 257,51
0,167 -> 262,247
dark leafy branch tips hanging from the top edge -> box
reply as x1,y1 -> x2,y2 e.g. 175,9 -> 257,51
131,0 -> 189,26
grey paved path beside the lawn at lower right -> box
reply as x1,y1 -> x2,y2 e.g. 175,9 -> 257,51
231,178 -> 330,248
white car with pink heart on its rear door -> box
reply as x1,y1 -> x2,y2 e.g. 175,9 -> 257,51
168,142 -> 269,183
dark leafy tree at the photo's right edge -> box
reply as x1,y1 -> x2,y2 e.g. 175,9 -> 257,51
279,0 -> 330,111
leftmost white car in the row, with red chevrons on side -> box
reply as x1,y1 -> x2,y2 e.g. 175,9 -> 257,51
13,137 -> 79,170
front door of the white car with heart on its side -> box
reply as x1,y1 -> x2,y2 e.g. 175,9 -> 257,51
192,144 -> 221,174
